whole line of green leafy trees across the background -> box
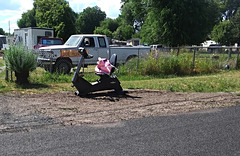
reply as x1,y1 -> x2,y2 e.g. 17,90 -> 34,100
0,0 -> 240,46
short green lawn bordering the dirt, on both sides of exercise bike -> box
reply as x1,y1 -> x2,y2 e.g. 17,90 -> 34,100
0,66 -> 240,94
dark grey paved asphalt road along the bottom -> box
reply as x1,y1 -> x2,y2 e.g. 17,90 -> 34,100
0,106 -> 240,156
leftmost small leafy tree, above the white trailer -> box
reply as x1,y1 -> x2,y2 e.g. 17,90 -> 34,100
17,8 -> 37,28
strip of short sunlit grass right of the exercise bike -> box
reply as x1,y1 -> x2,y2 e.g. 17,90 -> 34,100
122,71 -> 240,92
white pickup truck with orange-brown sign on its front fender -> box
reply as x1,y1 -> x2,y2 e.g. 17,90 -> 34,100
37,34 -> 151,73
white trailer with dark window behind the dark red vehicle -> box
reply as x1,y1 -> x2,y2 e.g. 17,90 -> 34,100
13,27 -> 54,50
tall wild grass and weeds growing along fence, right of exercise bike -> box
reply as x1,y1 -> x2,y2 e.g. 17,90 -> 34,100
120,53 -> 222,76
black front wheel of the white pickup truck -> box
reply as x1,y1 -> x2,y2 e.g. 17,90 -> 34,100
56,59 -> 71,74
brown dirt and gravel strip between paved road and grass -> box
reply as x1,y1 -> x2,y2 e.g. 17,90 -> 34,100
0,90 -> 240,133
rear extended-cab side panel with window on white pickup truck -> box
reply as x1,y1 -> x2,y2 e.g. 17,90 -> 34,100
97,37 -> 110,59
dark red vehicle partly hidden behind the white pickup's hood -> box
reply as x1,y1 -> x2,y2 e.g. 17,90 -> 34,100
33,37 -> 64,50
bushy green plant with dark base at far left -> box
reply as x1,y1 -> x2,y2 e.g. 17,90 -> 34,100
4,45 -> 37,84
